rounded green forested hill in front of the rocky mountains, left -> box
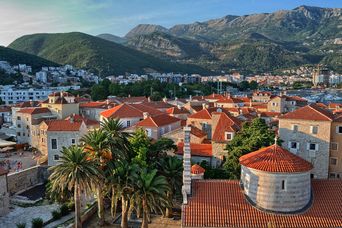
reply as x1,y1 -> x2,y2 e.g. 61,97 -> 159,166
9,32 -> 208,76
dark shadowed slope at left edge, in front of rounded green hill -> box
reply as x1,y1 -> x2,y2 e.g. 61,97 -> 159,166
0,46 -> 59,71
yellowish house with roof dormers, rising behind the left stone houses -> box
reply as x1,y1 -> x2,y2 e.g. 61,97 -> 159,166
41,92 -> 80,119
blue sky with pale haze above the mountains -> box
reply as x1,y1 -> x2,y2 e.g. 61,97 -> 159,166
0,0 -> 342,46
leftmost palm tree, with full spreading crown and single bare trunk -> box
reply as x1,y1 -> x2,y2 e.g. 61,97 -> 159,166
49,146 -> 99,228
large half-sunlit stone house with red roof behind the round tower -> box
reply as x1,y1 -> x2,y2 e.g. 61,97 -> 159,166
279,104 -> 334,179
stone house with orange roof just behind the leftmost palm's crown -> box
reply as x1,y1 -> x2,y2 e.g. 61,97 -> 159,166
32,118 -> 88,166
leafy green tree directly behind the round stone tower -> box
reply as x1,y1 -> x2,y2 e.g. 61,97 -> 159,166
223,118 -> 275,179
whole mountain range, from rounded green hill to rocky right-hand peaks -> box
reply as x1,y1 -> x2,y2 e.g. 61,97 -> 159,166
3,6 -> 342,75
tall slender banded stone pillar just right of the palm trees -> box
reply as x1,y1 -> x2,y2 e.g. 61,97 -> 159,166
182,127 -> 191,204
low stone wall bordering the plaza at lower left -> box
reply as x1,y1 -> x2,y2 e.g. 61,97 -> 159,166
7,166 -> 49,195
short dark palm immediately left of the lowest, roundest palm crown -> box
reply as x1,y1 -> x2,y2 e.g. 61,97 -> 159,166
107,160 -> 137,228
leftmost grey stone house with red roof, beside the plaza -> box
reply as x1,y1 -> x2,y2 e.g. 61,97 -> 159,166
14,108 -> 56,144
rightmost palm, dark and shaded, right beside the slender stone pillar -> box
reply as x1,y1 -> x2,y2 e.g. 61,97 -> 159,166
158,157 -> 183,218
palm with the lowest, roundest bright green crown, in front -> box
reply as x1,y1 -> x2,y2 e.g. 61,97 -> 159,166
131,169 -> 170,228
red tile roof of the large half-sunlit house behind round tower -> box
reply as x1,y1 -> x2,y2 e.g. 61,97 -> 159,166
279,104 -> 334,121
